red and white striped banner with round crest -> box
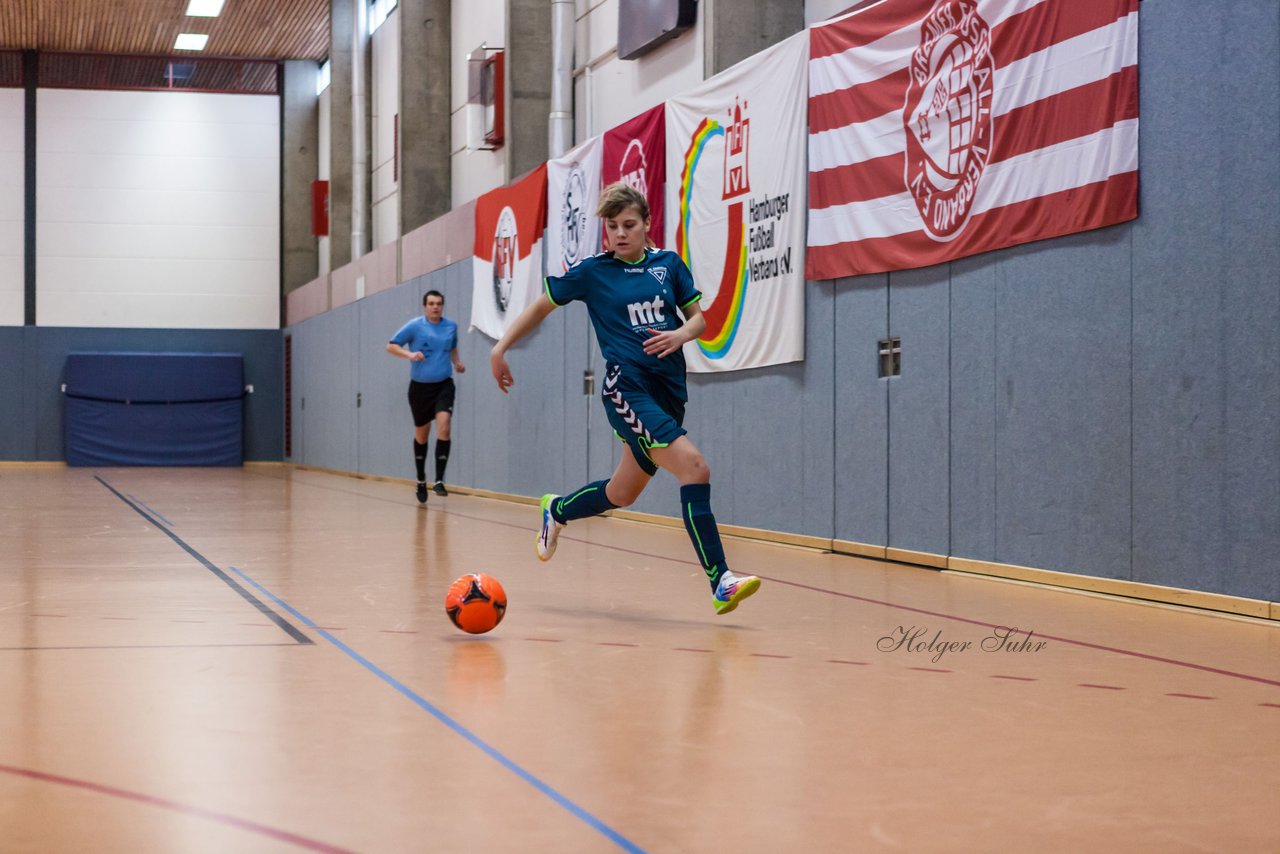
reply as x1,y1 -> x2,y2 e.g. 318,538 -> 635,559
805,0 -> 1138,279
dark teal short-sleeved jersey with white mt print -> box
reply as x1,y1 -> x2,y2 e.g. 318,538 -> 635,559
547,248 -> 703,387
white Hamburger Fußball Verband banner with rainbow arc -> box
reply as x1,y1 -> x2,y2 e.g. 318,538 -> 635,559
666,32 -> 809,373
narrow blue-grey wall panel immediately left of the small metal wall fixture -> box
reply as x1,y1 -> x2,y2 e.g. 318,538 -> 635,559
833,275 -> 888,545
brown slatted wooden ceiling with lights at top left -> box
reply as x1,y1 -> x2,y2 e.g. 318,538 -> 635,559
0,0 -> 329,60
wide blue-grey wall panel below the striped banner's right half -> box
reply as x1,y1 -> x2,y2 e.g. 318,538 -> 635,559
996,227 -> 1132,579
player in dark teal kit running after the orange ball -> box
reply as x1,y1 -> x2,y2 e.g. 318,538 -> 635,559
489,183 -> 760,613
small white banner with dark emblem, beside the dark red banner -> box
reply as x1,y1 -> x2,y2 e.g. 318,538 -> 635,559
543,137 -> 600,275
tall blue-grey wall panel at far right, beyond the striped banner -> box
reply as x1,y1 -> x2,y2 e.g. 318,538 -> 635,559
1133,0 -> 1280,600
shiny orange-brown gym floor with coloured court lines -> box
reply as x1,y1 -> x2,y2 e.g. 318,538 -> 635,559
0,466 -> 1280,853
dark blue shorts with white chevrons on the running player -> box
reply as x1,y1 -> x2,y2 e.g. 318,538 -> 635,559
600,365 -> 687,475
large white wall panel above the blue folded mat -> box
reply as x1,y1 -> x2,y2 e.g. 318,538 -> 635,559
36,90 -> 280,329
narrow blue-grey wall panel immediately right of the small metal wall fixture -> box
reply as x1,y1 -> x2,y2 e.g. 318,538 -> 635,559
887,265 -> 951,554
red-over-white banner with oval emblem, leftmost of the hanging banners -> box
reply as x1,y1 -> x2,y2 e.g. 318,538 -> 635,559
471,164 -> 547,338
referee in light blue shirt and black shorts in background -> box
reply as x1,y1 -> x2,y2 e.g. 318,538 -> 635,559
387,291 -> 466,504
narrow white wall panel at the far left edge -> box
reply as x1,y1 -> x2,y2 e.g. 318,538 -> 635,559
0,88 -> 26,326
